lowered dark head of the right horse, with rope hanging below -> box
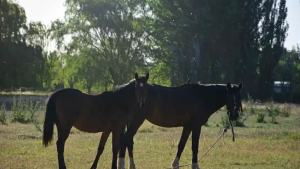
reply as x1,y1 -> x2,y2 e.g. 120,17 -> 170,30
226,82 -> 243,120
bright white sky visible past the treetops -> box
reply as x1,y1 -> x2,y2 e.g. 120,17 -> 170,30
17,0 -> 300,50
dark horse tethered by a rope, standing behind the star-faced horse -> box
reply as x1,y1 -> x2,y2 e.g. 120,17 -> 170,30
118,80 -> 243,169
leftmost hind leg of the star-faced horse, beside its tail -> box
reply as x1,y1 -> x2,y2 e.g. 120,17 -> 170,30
56,127 -> 71,169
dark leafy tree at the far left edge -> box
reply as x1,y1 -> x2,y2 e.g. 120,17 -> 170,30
0,0 -> 45,89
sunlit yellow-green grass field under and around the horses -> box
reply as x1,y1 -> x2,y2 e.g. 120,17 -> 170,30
0,102 -> 300,169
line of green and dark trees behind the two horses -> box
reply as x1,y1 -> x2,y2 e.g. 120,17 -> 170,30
0,0 -> 300,100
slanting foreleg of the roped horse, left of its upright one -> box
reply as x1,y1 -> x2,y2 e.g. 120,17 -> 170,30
172,127 -> 192,168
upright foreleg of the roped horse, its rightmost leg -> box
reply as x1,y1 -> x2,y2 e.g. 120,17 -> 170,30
192,127 -> 201,169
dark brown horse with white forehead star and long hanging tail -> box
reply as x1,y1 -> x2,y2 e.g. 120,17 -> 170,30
43,73 -> 149,169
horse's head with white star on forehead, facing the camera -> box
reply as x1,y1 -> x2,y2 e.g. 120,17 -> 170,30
135,73 -> 149,107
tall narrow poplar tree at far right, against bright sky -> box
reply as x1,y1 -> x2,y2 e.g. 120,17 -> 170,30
257,0 -> 288,100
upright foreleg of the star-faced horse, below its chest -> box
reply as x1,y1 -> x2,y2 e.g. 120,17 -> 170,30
111,126 -> 122,169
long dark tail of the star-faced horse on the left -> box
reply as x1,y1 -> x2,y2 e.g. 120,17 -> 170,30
43,93 -> 57,147
